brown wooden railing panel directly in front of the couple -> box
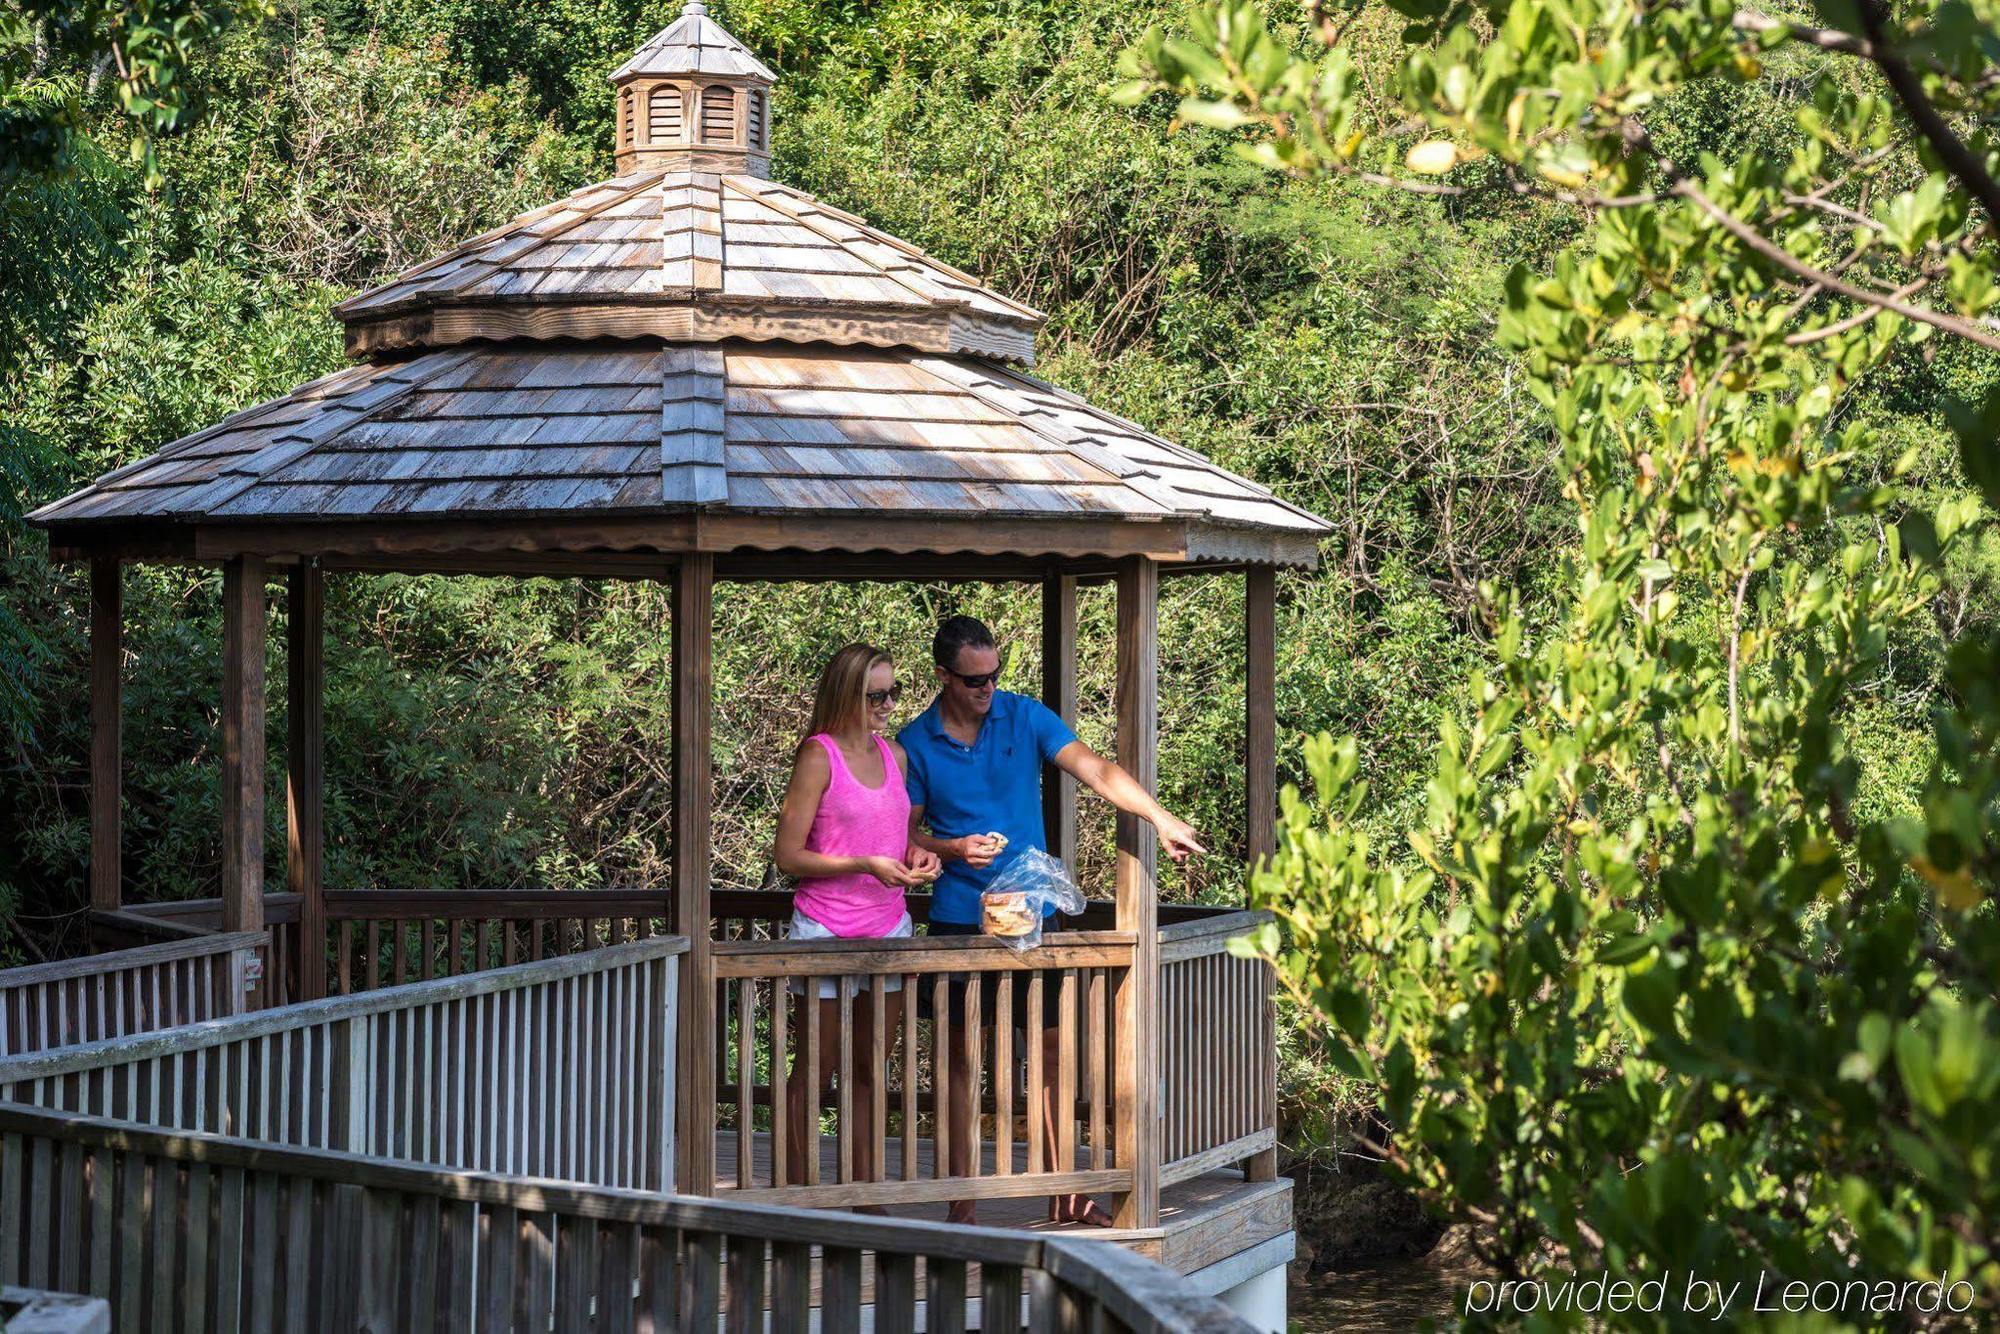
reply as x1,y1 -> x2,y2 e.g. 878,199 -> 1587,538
714,932 -> 1132,1206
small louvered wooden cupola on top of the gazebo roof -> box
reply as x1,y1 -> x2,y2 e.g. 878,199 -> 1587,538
612,0 -> 778,176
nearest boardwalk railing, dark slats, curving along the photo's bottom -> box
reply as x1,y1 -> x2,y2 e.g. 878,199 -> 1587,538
0,1102 -> 1248,1334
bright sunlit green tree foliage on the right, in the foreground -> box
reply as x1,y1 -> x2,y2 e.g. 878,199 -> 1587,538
1122,0 -> 2000,1324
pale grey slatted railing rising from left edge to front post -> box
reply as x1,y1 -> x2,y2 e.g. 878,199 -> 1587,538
0,936 -> 688,1190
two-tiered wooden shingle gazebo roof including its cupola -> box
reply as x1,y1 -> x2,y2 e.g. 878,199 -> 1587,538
32,0 -> 1326,564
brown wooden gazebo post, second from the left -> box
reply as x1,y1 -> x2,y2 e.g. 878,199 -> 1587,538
222,556 -> 264,960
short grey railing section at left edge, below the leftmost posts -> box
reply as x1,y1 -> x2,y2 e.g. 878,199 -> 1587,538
0,932 -> 270,1058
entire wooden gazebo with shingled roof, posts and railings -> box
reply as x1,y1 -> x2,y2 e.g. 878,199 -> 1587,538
32,0 -> 1326,1296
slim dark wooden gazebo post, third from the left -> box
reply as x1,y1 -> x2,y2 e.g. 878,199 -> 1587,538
284,560 -> 326,1000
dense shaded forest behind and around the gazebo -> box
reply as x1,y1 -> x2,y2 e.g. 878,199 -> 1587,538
0,0 -> 1994,1140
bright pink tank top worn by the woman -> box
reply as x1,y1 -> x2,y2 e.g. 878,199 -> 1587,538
792,732 -> 910,936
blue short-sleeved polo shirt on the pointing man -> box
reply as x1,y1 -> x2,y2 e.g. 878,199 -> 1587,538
896,690 -> 1076,922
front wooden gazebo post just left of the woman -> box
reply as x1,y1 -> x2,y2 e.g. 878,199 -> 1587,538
672,552 -> 716,1196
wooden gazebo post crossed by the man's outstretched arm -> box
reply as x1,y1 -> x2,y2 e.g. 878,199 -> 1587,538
1116,556 -> 1160,1228
